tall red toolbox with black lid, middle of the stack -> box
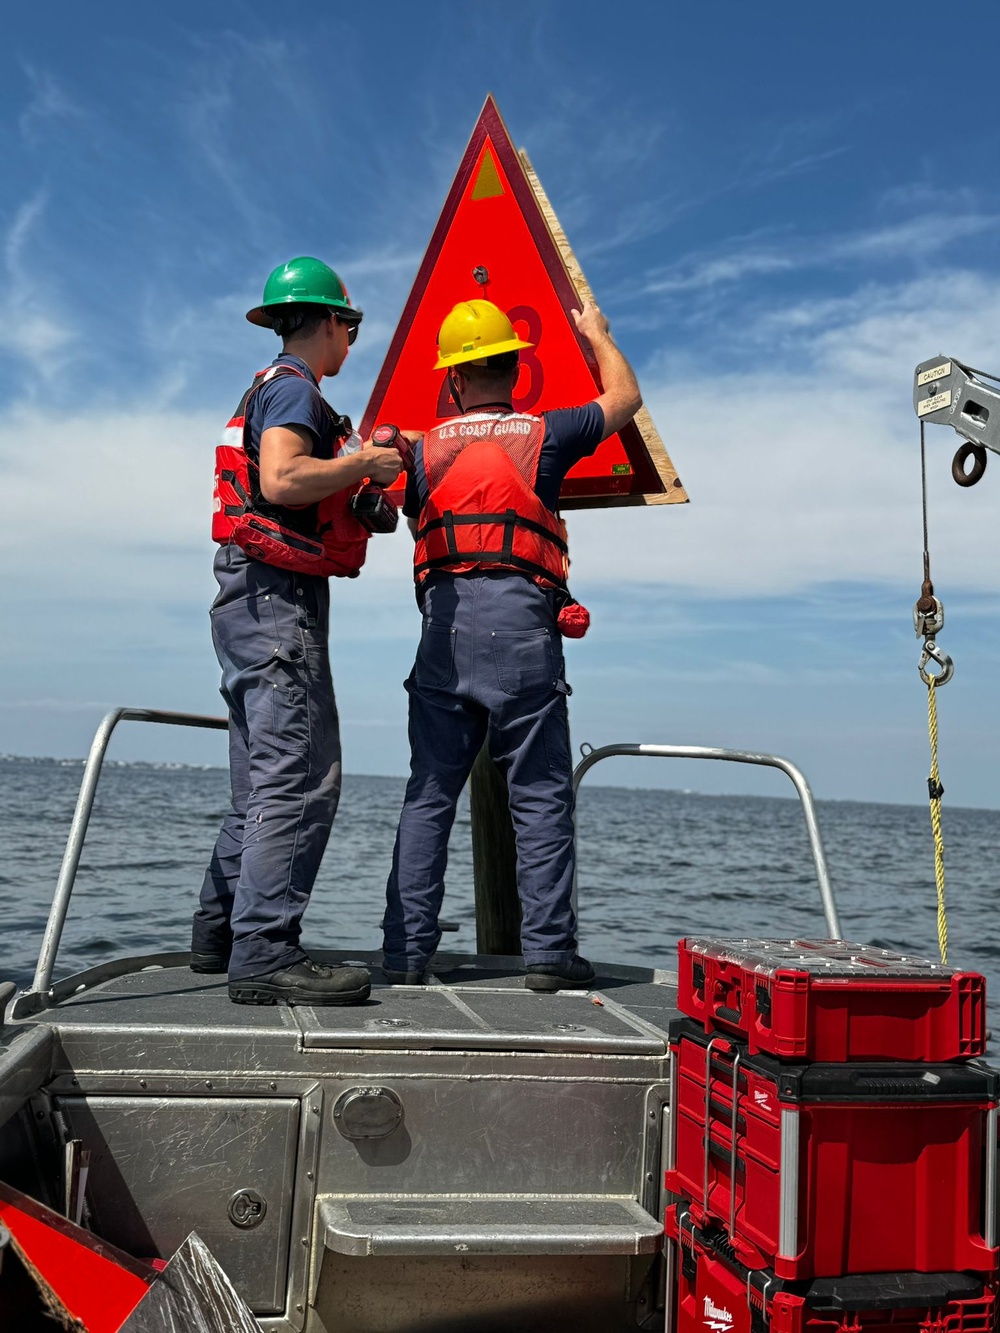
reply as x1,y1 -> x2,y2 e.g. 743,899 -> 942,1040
665,1018 -> 1000,1280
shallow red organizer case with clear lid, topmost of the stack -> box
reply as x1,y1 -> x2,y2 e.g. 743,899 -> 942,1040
677,938 -> 987,1062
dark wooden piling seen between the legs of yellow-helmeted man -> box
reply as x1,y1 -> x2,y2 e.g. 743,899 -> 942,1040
469,745 -> 521,954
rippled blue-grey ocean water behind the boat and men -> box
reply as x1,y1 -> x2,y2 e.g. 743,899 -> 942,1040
0,758 -> 1000,994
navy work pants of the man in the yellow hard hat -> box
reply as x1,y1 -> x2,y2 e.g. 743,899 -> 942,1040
383,573 -> 576,972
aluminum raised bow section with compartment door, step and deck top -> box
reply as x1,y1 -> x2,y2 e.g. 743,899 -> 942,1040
0,950 -> 676,1333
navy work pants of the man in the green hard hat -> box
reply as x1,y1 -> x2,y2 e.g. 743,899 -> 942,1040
192,547 -> 340,981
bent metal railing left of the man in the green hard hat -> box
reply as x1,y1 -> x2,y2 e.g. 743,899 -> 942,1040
13,708 -> 229,1018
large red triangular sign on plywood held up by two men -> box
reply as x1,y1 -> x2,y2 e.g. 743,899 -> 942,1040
361,97 -> 688,509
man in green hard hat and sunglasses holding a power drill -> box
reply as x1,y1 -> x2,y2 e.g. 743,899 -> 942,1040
191,257 -> 401,1005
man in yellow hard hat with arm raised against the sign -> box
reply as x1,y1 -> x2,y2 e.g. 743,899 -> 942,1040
383,300 -> 641,990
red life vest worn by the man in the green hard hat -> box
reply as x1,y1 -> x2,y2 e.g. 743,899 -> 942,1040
212,364 -> 368,579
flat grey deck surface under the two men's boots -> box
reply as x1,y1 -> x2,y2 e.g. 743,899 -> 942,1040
8,952 -> 676,1069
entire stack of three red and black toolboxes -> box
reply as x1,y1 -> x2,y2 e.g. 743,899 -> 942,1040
665,938 -> 1000,1333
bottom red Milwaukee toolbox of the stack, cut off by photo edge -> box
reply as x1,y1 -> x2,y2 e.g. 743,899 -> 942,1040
665,1204 -> 997,1333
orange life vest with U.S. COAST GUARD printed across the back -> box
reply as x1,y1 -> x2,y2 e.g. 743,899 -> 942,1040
413,412 -> 569,591
